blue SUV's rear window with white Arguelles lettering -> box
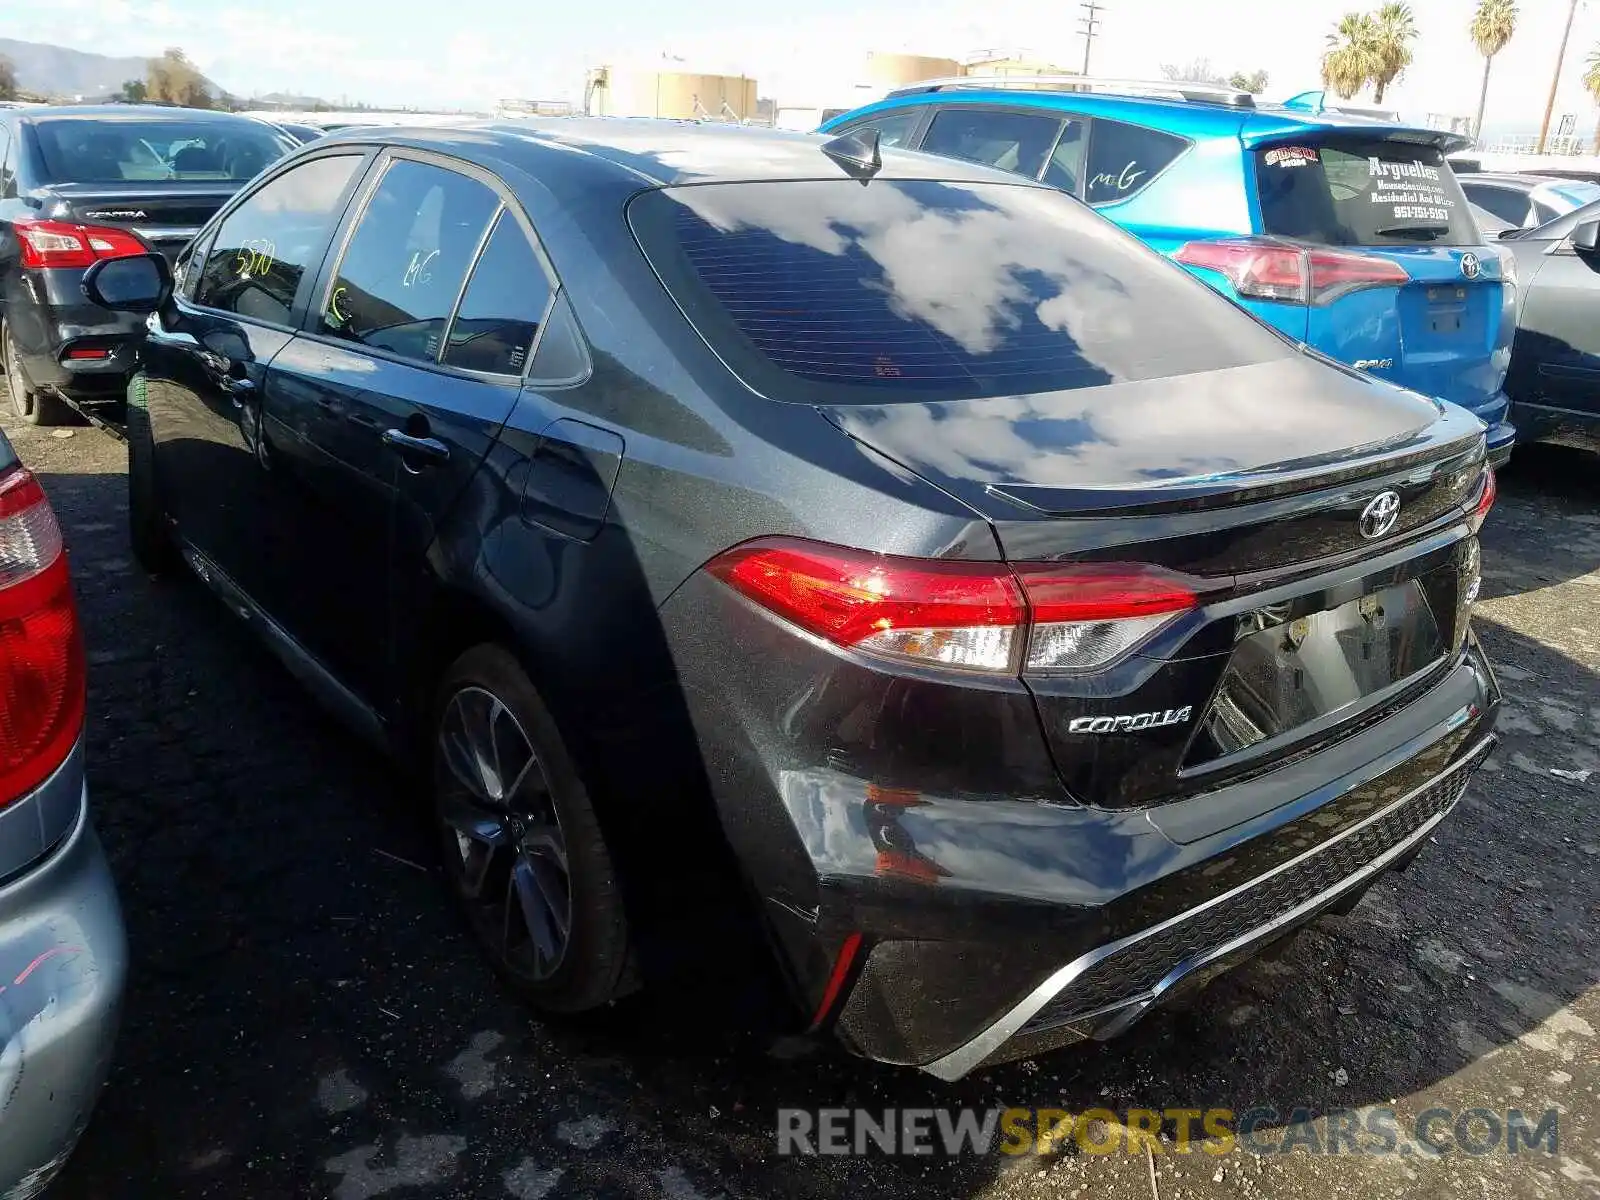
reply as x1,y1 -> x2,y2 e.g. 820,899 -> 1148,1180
1256,139 -> 1482,246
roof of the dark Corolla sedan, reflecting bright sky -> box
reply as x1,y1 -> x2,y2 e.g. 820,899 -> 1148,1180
312,117 -> 1034,189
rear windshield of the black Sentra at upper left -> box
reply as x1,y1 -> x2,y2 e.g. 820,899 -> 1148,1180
34,117 -> 294,184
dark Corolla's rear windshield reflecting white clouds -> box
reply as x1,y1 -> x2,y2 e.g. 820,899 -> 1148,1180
629,178 -> 1290,403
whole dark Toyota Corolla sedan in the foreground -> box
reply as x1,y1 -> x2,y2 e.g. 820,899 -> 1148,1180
86,120 -> 1499,1078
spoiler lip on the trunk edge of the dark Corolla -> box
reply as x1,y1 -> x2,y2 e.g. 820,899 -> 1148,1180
984,410 -> 1488,518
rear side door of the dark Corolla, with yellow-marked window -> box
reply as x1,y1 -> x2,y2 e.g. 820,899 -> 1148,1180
264,152 -> 537,709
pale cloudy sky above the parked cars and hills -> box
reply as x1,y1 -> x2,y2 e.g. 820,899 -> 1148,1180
9,0 -> 1600,130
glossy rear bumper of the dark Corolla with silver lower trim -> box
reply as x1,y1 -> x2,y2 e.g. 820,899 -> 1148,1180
664,569 -> 1499,1078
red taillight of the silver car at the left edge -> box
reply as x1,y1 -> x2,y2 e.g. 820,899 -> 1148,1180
0,467 -> 85,808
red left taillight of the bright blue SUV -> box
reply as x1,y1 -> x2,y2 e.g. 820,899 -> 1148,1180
1173,237 -> 1411,304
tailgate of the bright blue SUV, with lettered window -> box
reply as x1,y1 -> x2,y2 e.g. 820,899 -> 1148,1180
1253,134 -> 1514,414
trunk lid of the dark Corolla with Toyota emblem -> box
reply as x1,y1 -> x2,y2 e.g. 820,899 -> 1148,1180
826,357 -> 1483,806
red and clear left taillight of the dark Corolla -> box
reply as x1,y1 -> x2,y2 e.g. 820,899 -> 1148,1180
707,539 -> 1197,675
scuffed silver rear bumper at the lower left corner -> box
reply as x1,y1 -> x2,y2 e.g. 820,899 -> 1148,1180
0,787 -> 128,1200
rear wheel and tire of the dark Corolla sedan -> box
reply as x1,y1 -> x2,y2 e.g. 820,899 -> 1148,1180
429,645 -> 635,1013
